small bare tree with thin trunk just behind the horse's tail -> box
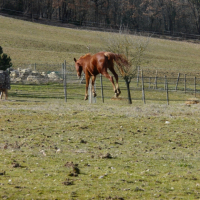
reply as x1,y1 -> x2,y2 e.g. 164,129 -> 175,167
105,28 -> 149,104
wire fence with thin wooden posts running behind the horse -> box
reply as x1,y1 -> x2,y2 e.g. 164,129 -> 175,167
9,64 -> 200,104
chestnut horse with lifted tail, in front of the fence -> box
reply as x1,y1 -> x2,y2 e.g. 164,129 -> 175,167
74,52 -> 128,100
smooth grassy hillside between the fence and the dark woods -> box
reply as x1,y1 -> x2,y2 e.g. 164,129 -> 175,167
0,13 -> 200,74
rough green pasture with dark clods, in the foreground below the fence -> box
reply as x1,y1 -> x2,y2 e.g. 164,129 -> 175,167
0,85 -> 200,200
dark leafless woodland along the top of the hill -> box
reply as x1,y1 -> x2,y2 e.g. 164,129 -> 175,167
0,0 -> 200,35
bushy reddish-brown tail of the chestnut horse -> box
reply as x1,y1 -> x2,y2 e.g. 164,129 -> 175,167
104,52 -> 130,75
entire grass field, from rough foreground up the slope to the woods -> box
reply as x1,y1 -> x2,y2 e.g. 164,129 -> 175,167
0,16 -> 200,200
